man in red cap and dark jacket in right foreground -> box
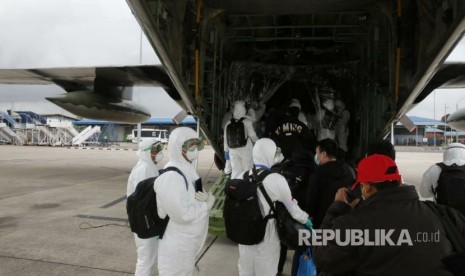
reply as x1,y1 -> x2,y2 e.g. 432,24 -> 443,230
314,154 -> 465,275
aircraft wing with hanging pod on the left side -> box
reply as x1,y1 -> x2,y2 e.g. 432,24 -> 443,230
0,65 -> 184,123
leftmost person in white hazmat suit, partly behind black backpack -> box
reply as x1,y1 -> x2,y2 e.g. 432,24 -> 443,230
127,138 -> 163,276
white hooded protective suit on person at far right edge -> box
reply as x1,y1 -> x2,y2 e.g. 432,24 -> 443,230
420,143 -> 465,200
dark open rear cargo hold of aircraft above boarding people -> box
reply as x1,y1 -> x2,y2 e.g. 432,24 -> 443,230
122,0 -> 465,158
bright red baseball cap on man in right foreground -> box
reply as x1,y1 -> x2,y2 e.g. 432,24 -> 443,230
352,154 -> 401,189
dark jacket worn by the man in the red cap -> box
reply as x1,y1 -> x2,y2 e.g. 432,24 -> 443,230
314,185 -> 465,276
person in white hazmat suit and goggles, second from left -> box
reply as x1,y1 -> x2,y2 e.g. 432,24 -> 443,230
154,127 -> 215,276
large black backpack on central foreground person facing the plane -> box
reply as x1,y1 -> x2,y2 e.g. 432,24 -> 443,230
223,167 -> 271,245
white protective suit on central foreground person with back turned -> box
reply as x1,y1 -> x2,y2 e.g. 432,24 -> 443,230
238,138 -> 308,276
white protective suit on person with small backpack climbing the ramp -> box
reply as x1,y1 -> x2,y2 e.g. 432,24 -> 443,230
224,101 -> 258,179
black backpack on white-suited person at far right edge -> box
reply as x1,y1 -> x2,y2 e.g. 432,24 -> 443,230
434,162 -> 465,215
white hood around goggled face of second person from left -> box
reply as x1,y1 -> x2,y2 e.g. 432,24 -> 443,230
168,127 -> 199,165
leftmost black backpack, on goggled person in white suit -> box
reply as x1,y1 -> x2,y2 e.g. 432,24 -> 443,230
126,167 -> 187,239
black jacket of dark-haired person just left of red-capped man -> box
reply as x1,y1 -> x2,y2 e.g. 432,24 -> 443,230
305,161 -> 355,228
